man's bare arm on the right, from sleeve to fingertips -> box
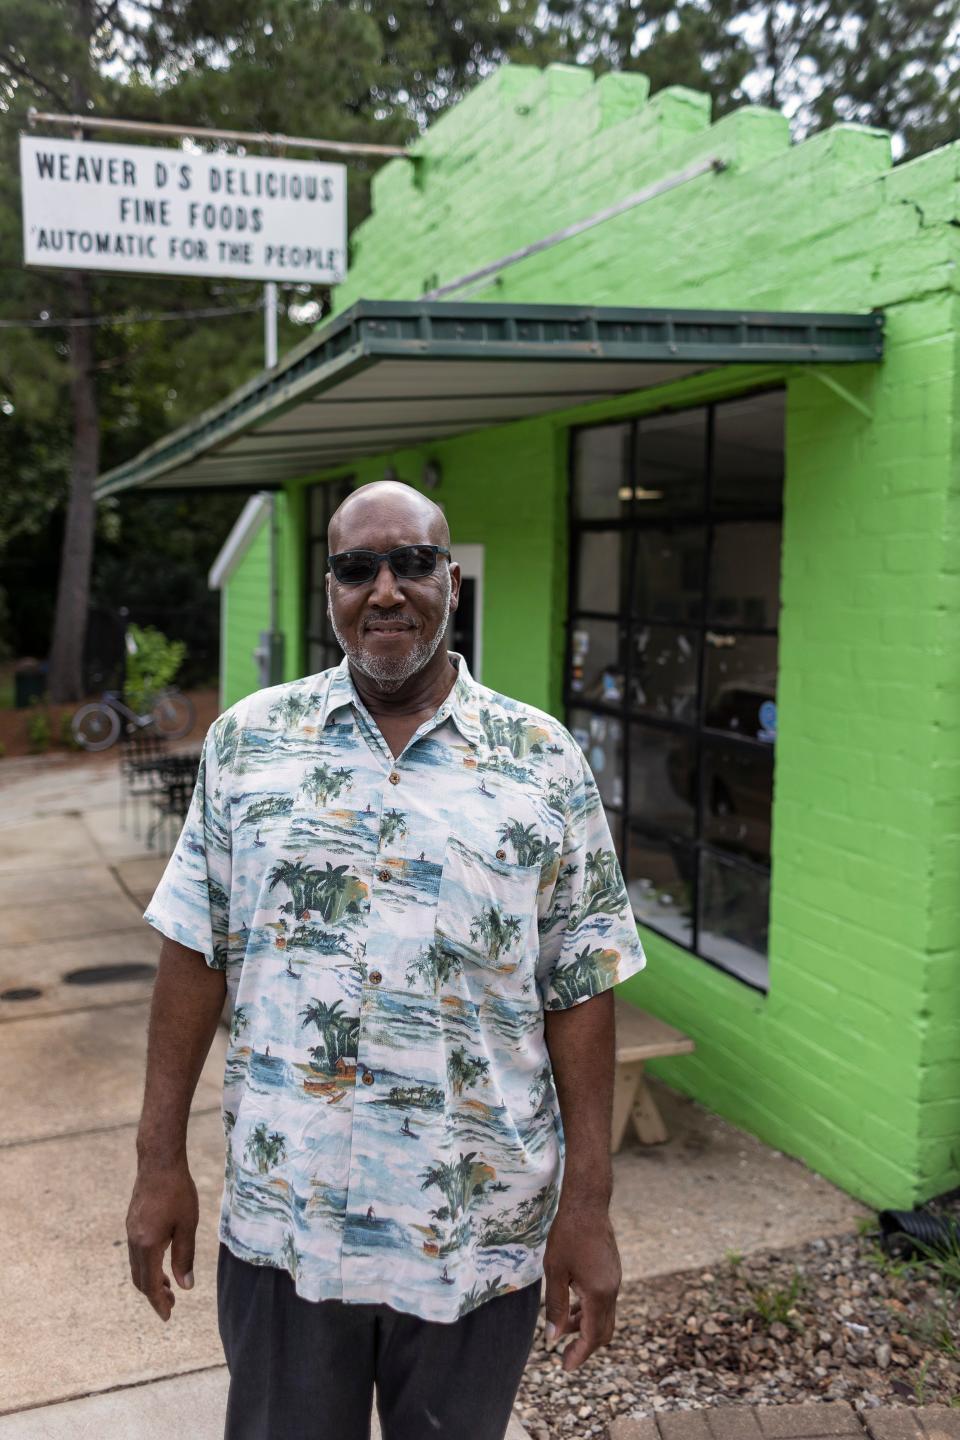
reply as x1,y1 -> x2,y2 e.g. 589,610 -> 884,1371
544,991 -> 620,1369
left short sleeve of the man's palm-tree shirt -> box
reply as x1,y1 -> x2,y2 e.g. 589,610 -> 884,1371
144,716 -> 236,971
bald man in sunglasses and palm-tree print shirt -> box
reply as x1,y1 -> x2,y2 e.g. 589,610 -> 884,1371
128,482 -> 643,1440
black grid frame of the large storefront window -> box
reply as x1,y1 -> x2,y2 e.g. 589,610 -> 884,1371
563,383 -> 787,995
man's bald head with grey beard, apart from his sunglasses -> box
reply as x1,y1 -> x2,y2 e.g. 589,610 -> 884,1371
327,480 -> 461,693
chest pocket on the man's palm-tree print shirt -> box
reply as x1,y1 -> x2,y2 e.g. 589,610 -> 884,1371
435,835 -> 541,976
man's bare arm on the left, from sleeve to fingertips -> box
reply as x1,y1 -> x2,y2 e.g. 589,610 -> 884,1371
127,939 -> 226,1320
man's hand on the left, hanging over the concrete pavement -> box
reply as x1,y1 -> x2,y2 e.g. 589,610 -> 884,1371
127,1159 -> 200,1320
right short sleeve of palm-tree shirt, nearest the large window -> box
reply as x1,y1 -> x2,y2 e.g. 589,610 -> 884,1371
537,739 -> 646,1009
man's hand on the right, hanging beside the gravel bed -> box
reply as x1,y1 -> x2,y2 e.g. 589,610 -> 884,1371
544,1201 -> 620,1371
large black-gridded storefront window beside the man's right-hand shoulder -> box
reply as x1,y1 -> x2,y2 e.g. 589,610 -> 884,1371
567,390 -> 784,989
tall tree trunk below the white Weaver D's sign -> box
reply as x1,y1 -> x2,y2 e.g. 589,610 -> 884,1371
49,272 -> 99,704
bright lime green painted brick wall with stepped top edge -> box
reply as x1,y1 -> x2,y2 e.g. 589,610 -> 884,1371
217,66 -> 960,1205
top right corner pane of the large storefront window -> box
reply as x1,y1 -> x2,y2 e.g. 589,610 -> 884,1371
714,390 -> 784,510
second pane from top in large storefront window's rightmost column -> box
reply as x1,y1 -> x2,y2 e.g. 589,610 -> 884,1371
707,520 -> 782,629
